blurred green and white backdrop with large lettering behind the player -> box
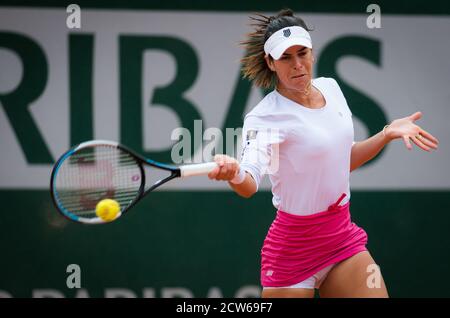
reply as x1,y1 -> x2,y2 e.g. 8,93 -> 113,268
0,1 -> 450,297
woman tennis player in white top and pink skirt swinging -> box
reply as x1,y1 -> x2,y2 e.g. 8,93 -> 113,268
208,9 -> 438,297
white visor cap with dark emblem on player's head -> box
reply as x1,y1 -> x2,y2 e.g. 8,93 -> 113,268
264,26 -> 312,60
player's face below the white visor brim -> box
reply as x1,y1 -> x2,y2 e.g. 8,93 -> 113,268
266,45 -> 314,91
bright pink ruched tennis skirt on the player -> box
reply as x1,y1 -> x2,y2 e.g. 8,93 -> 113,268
261,194 -> 367,287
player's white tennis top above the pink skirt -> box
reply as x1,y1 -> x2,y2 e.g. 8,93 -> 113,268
240,77 -> 354,215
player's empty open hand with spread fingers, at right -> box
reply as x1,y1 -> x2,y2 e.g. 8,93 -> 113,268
385,112 -> 439,152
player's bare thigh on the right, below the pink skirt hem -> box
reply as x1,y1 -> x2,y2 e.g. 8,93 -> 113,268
319,251 -> 389,298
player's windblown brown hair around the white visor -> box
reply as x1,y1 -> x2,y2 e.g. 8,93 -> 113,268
240,9 -> 312,89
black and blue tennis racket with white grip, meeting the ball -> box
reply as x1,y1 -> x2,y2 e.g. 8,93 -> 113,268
50,140 -> 217,224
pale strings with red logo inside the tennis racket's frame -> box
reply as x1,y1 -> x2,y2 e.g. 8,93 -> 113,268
55,145 -> 142,218
